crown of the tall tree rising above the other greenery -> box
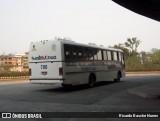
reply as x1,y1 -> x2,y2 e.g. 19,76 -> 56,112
124,37 -> 141,53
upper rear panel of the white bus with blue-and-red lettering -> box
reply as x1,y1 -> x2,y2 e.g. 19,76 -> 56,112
29,41 -> 62,63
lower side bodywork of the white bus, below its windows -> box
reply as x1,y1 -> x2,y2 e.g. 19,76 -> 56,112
64,61 -> 125,85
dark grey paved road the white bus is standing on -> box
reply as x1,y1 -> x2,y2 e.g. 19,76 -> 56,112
0,75 -> 160,121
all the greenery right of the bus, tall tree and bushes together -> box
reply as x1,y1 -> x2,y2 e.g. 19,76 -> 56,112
114,37 -> 160,71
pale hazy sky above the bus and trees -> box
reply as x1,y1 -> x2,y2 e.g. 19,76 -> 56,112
0,0 -> 160,54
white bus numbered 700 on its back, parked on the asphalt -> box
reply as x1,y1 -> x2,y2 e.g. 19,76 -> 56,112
29,39 -> 125,86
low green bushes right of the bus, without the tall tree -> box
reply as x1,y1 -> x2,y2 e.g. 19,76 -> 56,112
126,49 -> 160,71
